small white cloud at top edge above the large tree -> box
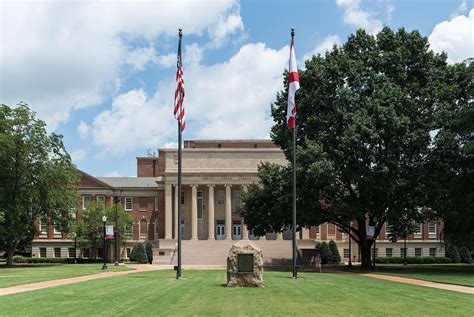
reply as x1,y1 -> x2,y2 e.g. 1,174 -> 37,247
336,0 -> 386,34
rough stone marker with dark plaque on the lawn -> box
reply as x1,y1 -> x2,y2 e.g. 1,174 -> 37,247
227,240 -> 263,287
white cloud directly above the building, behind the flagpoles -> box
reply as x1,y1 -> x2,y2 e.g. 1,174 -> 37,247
92,43 -> 289,154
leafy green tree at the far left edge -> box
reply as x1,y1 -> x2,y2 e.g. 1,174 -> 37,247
0,103 -> 79,265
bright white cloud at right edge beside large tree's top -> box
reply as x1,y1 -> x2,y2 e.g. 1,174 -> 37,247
428,9 -> 474,63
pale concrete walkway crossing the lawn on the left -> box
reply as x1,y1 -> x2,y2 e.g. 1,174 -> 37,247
0,264 -> 162,296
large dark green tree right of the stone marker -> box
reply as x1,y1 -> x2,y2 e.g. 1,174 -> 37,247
240,28 -> 472,267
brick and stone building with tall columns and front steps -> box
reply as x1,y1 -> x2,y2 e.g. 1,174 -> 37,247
32,140 -> 444,265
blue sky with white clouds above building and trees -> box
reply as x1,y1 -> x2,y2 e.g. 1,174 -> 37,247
0,0 -> 474,176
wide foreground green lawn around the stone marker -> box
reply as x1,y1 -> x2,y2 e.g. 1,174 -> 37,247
0,271 -> 474,317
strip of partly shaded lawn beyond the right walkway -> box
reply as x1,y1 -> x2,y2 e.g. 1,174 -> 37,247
374,264 -> 474,287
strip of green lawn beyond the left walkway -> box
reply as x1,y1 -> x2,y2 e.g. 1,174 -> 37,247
0,263 -> 129,288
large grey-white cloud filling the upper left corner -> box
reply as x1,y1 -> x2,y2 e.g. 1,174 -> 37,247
0,0 -> 241,130
